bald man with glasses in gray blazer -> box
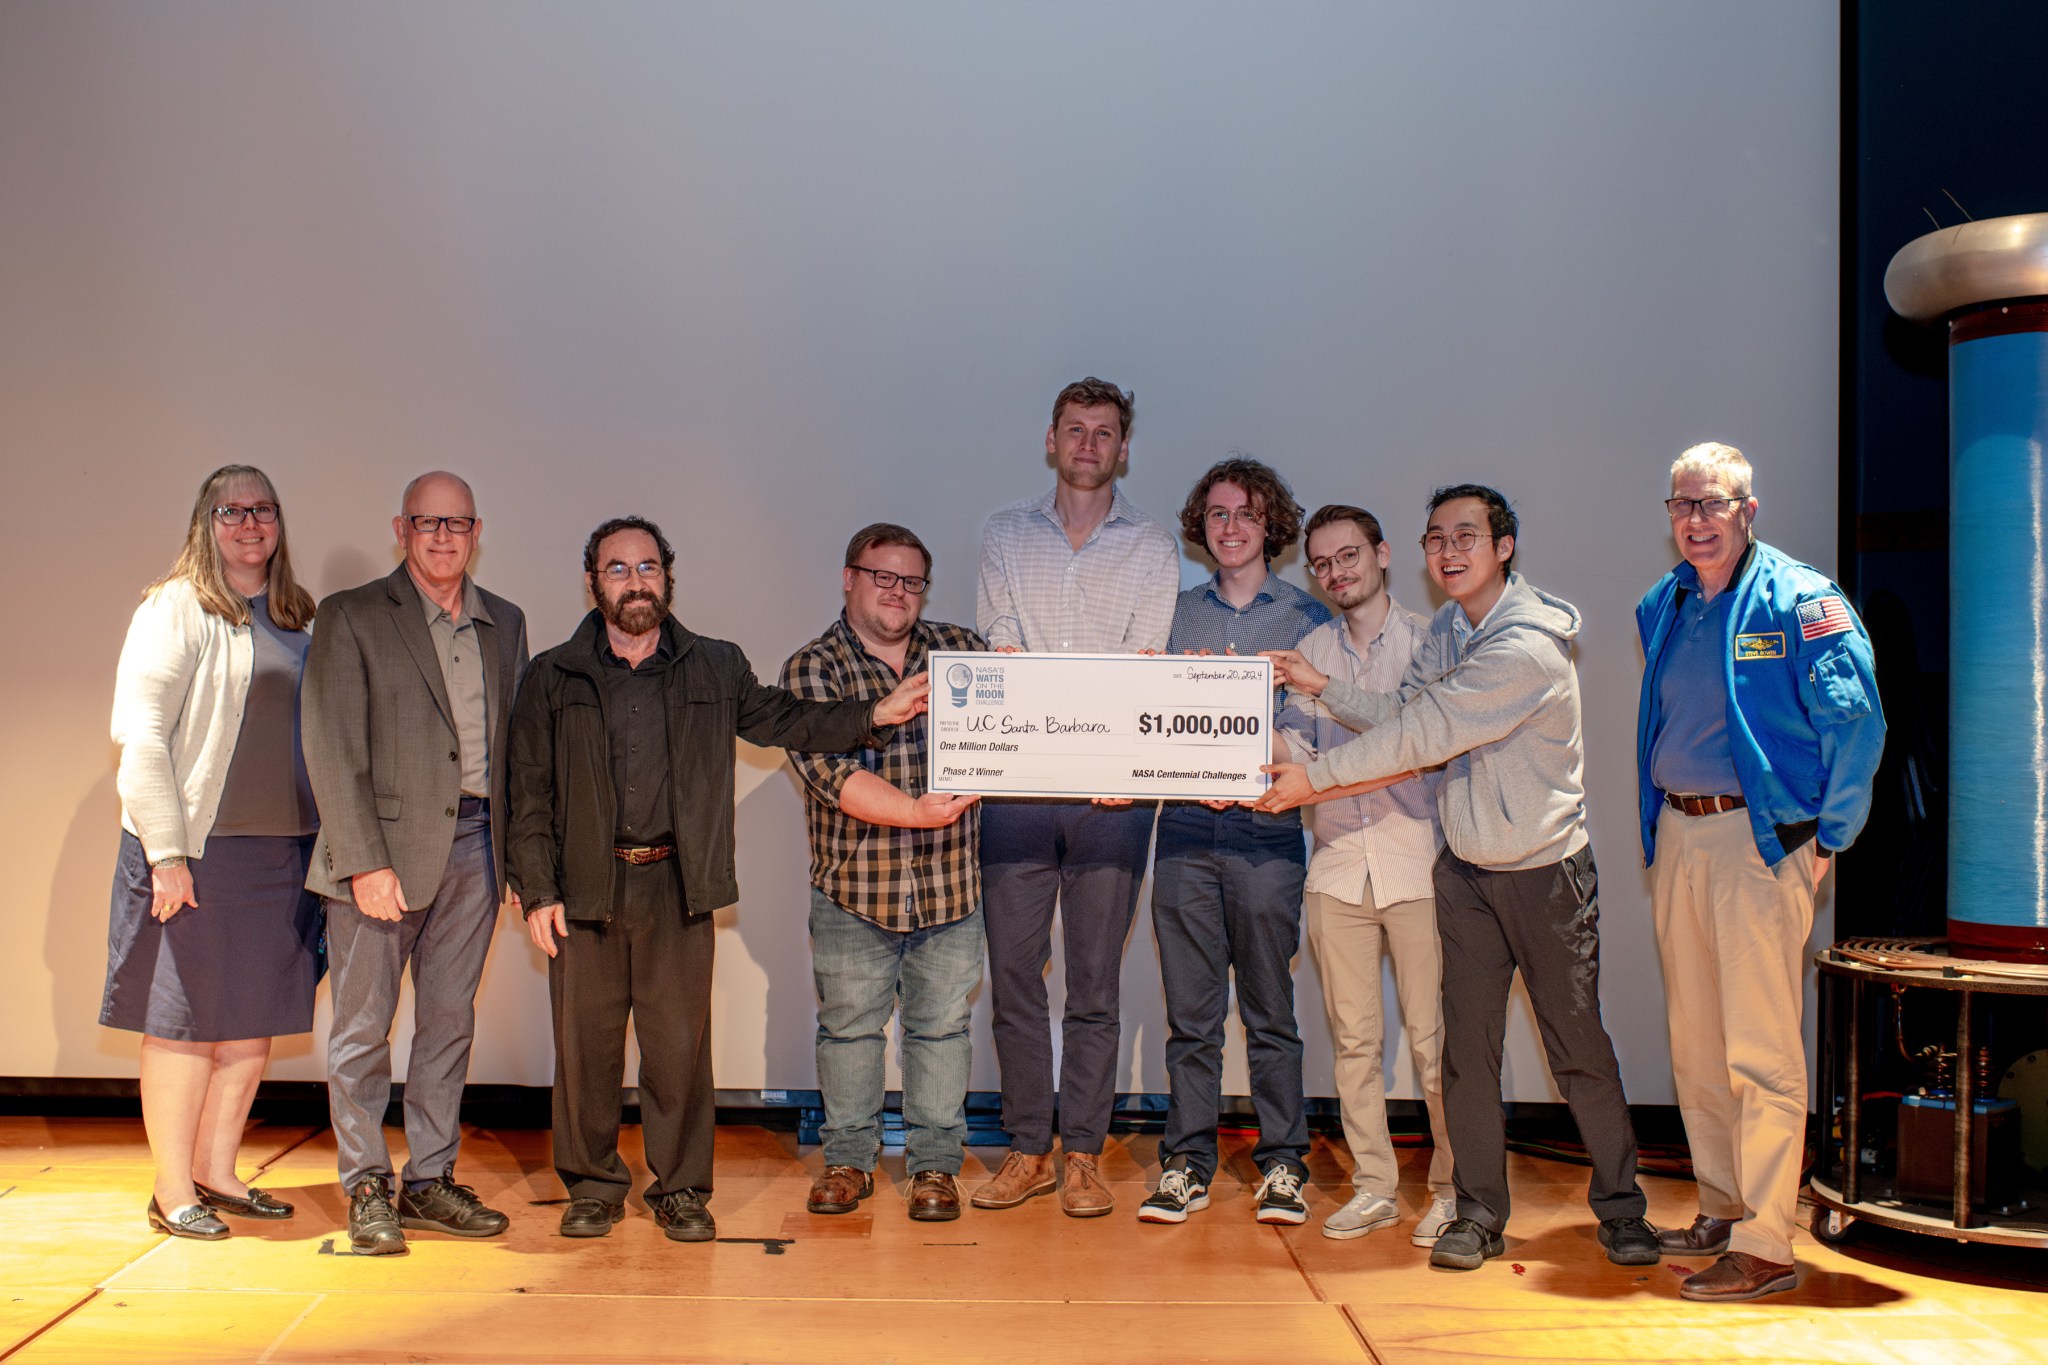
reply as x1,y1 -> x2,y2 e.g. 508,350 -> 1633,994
301,471 -> 526,1257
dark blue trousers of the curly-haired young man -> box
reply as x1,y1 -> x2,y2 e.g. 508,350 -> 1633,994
1153,802 -> 1309,1185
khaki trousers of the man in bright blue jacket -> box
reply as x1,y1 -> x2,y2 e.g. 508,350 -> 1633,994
1651,806 -> 1817,1263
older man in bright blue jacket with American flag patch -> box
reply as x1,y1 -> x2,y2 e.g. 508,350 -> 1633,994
1636,442 -> 1884,1302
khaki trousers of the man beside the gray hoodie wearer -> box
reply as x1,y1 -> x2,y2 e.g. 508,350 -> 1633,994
1303,882 -> 1456,1199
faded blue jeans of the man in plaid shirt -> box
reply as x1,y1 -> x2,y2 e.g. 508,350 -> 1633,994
811,886 -> 981,1175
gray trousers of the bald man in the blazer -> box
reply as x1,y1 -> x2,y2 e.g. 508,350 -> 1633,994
328,814 -> 498,1189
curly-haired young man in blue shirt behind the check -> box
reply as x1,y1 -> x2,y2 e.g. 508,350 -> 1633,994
1139,456 -> 1329,1224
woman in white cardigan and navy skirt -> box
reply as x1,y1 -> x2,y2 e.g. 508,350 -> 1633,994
100,465 -> 319,1240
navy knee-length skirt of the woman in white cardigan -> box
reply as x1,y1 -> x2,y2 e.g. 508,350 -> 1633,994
100,831 -> 322,1044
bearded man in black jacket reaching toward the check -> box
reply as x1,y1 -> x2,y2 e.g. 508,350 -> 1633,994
508,516 -> 926,1242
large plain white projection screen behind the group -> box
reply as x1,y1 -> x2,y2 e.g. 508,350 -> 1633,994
0,0 -> 1839,1103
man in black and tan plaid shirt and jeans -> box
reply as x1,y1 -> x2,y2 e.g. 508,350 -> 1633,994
782,522 -> 983,1222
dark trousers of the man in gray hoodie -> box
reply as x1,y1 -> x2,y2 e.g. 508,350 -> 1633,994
1434,845 -> 1649,1232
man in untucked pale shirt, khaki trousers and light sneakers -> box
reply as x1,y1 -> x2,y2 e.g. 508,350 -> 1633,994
1280,503 -> 1458,1246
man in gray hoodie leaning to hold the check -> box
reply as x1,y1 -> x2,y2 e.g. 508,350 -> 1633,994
1257,483 -> 1657,1271
